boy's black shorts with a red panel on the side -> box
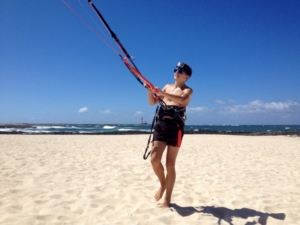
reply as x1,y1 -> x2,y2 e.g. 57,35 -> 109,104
153,119 -> 184,147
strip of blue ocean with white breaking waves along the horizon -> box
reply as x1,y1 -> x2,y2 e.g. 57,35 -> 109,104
0,124 -> 300,134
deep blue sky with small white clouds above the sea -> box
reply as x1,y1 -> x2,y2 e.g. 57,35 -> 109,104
0,0 -> 300,125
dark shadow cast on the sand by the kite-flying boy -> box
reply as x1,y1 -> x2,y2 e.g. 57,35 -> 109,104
170,204 -> 285,225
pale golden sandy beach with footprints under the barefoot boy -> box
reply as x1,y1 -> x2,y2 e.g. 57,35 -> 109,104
0,135 -> 300,225
